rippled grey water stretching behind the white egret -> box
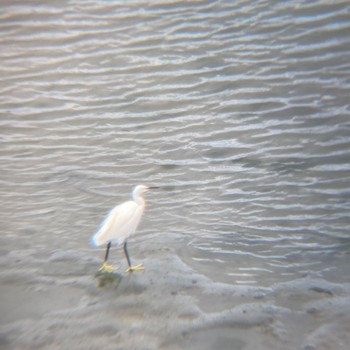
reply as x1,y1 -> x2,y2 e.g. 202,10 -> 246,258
0,1 -> 350,349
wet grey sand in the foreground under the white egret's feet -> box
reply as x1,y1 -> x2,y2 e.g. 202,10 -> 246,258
0,240 -> 350,350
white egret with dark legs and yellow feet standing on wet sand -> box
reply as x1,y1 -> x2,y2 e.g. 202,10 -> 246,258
91,185 -> 159,272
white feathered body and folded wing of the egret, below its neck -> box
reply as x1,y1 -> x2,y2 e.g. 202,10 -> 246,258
92,201 -> 142,246
